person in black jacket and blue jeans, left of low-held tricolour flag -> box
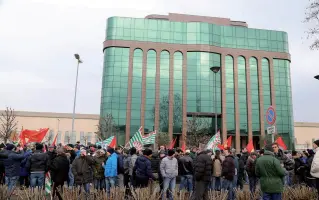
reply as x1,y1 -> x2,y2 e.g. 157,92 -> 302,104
26,143 -> 48,187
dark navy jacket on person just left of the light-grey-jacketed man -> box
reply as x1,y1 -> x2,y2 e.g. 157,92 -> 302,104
133,156 -> 155,179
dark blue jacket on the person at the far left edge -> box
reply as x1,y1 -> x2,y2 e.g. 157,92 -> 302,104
4,151 -> 24,177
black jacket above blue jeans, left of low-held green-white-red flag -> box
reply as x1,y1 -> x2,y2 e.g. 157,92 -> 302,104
26,150 -> 49,172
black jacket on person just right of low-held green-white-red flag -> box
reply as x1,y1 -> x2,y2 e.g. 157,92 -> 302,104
49,155 -> 70,183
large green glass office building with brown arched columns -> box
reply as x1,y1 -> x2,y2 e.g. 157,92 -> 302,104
101,13 -> 294,149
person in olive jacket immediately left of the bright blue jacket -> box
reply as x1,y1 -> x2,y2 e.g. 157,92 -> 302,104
93,149 -> 106,190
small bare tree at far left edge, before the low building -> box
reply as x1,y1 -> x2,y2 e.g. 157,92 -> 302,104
0,107 -> 18,143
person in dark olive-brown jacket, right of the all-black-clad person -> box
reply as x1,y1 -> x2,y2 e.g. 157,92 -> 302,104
72,150 -> 94,194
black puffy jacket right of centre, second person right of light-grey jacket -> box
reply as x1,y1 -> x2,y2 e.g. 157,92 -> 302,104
194,151 -> 213,182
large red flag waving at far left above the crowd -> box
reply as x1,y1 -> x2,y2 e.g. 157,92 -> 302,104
19,128 -> 49,145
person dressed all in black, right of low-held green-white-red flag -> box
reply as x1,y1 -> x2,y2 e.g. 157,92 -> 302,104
49,147 -> 70,200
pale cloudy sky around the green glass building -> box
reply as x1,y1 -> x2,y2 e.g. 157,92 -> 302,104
0,0 -> 319,122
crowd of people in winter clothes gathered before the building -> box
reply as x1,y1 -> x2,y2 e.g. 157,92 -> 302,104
0,140 -> 319,200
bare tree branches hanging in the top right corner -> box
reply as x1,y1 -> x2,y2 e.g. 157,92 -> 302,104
304,0 -> 319,50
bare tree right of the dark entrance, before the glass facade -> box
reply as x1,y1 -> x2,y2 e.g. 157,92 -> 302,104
186,115 -> 211,147
